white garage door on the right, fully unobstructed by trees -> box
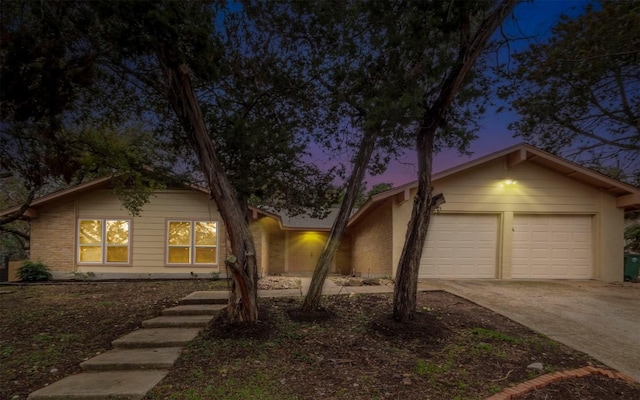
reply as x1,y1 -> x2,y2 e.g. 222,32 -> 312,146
511,215 -> 592,279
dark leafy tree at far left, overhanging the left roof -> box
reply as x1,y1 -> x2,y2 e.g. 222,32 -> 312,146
0,1 -> 170,241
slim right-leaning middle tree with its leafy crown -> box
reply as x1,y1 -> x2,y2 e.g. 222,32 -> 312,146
263,2 -> 424,312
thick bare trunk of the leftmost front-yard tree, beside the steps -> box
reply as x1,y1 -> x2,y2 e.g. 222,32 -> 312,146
159,61 -> 258,322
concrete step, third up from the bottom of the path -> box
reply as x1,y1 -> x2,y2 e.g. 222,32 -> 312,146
111,328 -> 201,349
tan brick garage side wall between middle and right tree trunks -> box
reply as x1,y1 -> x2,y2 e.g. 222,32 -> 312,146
351,200 -> 393,276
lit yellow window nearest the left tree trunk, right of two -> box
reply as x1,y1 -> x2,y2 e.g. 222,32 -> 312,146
167,221 -> 218,264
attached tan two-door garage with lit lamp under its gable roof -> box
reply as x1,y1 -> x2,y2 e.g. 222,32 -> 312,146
349,144 -> 640,282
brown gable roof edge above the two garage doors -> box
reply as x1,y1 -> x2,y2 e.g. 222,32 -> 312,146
349,143 -> 640,225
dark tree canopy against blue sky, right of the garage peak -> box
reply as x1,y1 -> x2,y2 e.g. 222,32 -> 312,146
501,0 -> 640,178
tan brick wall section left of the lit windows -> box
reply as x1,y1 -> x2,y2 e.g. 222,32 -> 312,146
31,201 -> 76,272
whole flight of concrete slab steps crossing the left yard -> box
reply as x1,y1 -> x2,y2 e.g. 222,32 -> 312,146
28,291 -> 229,400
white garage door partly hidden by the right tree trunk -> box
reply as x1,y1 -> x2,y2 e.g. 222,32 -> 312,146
419,214 -> 498,278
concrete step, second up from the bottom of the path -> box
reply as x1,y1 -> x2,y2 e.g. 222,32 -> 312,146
80,347 -> 182,371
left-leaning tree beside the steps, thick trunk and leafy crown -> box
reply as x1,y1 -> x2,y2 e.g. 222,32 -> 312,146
90,1 -> 342,322
